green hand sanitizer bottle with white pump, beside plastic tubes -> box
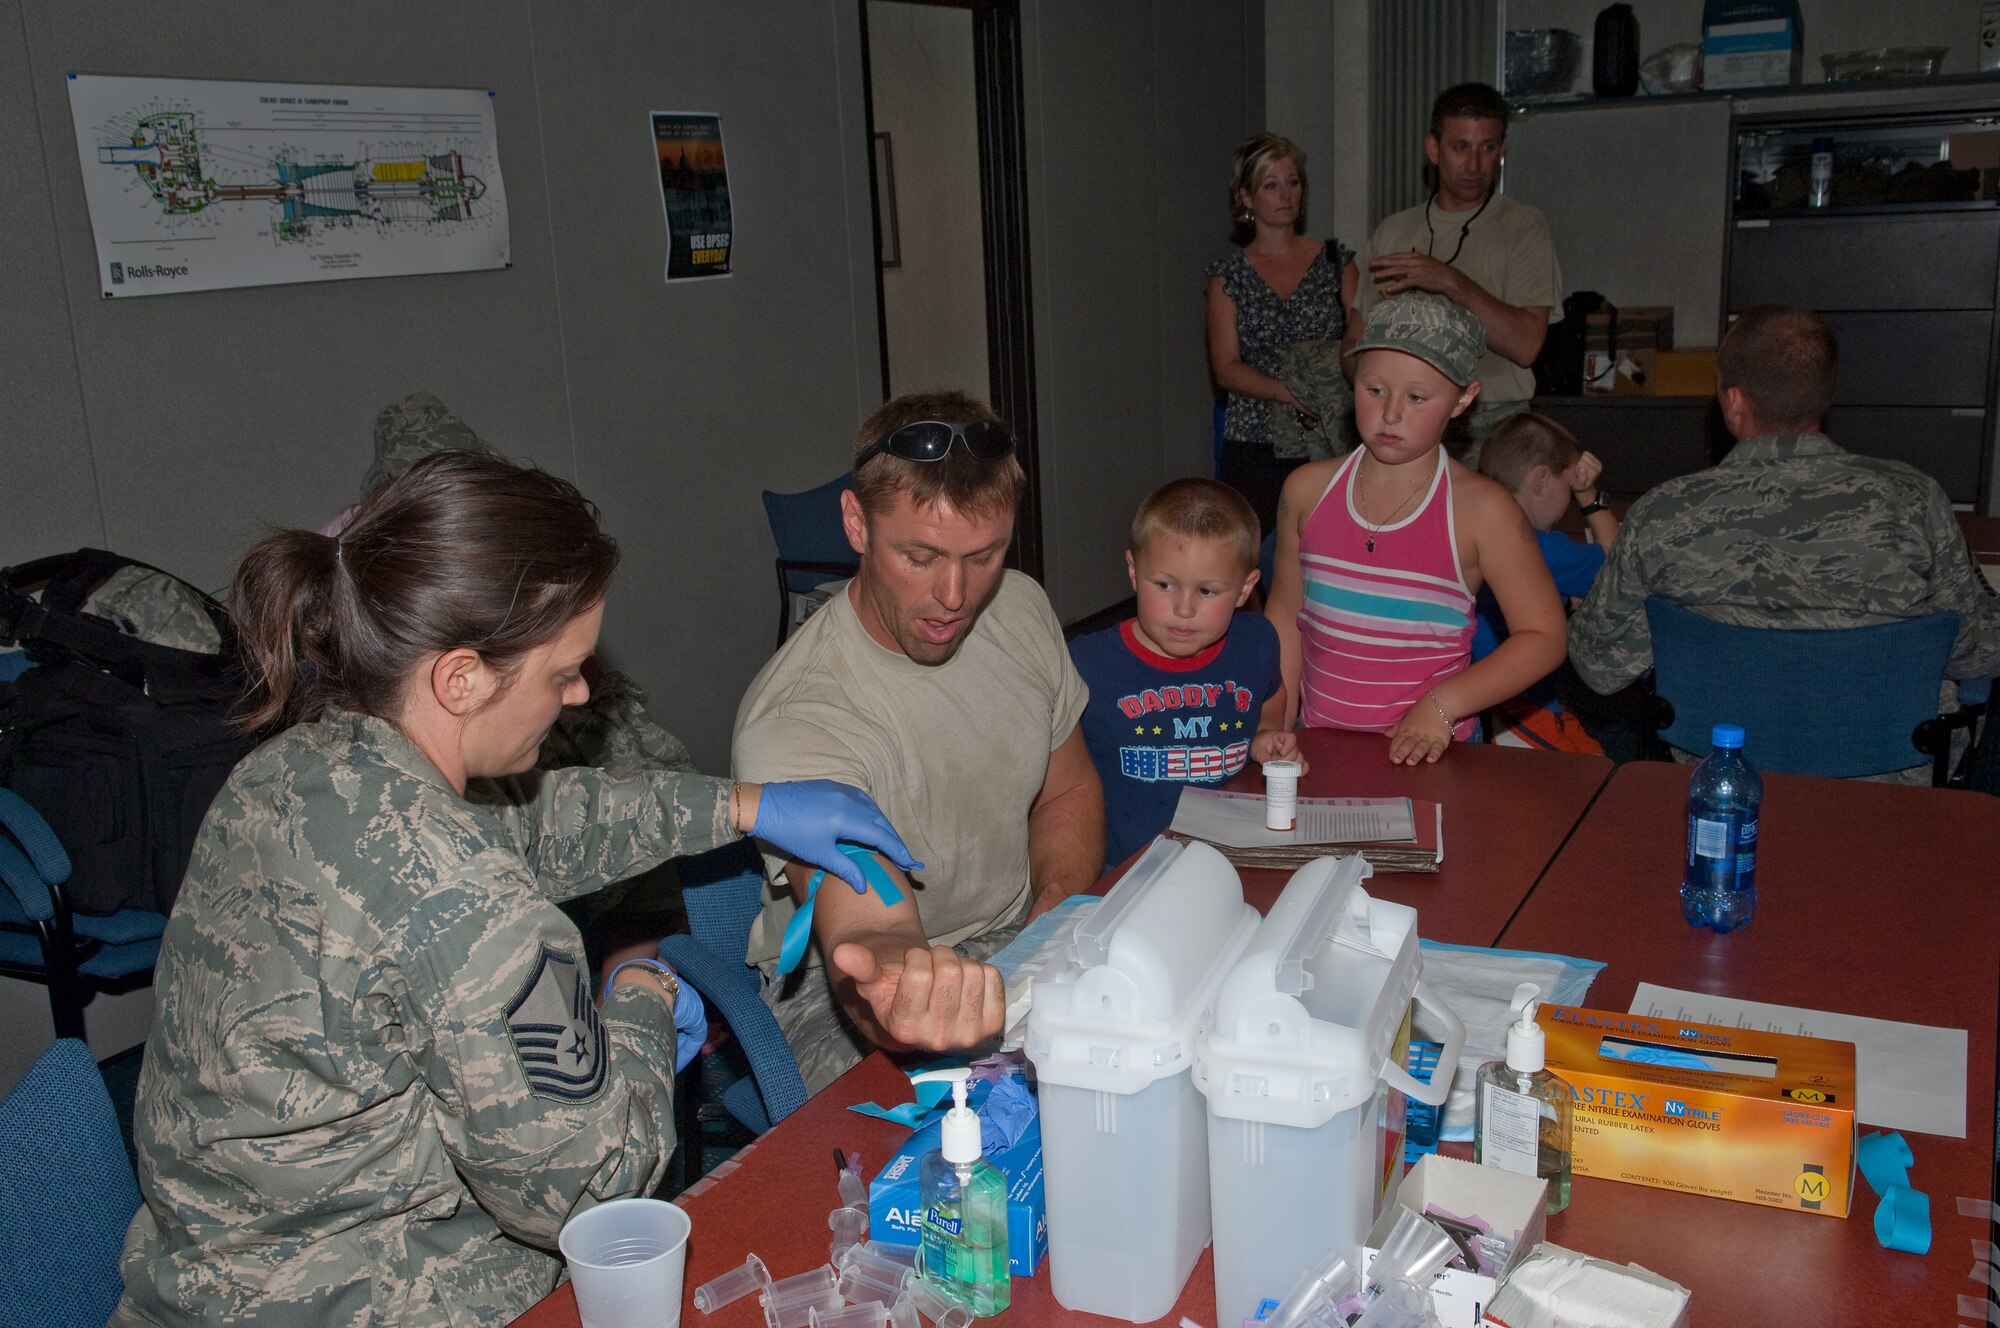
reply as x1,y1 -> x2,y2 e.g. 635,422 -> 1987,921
912,1068 -> 1012,1318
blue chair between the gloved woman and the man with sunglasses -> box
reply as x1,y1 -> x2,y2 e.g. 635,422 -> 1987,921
660,842 -> 810,1134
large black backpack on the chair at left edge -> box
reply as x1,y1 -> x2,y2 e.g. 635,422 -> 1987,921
0,548 -> 260,916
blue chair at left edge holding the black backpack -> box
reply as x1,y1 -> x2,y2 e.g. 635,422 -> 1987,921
0,788 -> 166,1038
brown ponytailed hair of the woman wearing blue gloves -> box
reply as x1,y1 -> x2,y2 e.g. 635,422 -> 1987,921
230,452 -> 618,730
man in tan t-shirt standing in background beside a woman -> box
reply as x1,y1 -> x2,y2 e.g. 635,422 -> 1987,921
1360,84 -> 1562,456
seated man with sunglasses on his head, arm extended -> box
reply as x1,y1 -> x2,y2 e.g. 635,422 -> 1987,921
734,392 -> 1104,1092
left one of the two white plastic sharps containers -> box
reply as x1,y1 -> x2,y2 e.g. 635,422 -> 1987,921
1028,840 -> 1258,1324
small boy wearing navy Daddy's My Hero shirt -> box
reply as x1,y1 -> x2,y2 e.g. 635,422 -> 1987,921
1070,480 -> 1304,866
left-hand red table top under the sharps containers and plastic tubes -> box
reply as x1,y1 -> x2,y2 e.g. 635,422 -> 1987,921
516,730 -> 1612,1328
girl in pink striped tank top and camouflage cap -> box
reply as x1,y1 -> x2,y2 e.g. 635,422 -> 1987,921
1266,292 -> 1564,764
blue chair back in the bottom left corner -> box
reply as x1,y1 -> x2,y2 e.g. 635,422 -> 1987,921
0,1038 -> 138,1328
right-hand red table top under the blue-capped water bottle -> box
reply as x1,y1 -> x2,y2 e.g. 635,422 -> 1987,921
1500,762 -> 2000,1326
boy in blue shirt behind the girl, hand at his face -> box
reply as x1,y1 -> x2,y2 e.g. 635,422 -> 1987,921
1472,410 -> 1618,660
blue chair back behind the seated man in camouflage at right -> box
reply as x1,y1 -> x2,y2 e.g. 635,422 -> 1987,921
1646,596 -> 1984,784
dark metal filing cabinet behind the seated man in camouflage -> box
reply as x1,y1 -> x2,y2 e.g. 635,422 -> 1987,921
1724,104 -> 2000,510
